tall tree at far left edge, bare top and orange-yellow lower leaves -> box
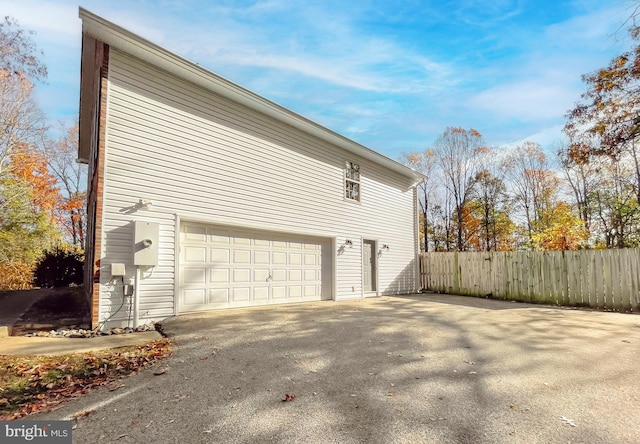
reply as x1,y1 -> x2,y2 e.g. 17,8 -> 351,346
0,17 -> 51,289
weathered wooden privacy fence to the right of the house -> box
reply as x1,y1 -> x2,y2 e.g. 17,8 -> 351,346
420,248 -> 640,312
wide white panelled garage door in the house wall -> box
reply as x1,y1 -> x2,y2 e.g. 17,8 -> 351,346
179,223 -> 331,312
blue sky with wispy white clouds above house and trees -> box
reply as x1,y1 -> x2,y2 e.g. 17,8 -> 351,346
0,0 -> 632,159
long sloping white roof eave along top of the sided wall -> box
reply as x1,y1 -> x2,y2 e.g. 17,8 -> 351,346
78,7 -> 424,183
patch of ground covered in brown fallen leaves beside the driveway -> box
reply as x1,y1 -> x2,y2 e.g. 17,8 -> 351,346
0,339 -> 171,419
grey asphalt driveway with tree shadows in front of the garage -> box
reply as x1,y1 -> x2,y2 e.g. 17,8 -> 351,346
39,295 -> 640,444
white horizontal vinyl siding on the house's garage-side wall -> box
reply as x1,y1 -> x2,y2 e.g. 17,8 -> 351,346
95,48 -> 417,321
